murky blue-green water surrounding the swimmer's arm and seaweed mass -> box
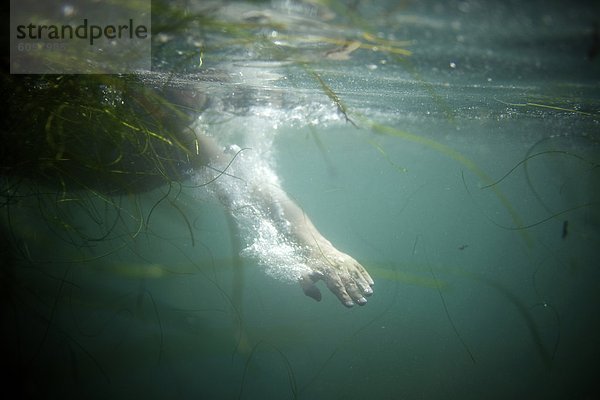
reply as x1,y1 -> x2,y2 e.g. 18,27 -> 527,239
2,1 -> 600,399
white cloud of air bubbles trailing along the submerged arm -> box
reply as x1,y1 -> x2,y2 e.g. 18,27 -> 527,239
194,109 -> 336,283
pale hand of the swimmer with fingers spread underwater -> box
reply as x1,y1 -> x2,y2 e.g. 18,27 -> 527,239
300,243 -> 374,307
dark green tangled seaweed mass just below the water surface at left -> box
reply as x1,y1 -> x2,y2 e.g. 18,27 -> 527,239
1,75 -> 202,193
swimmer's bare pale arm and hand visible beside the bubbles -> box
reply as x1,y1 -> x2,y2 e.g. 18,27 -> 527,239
197,134 -> 374,307
